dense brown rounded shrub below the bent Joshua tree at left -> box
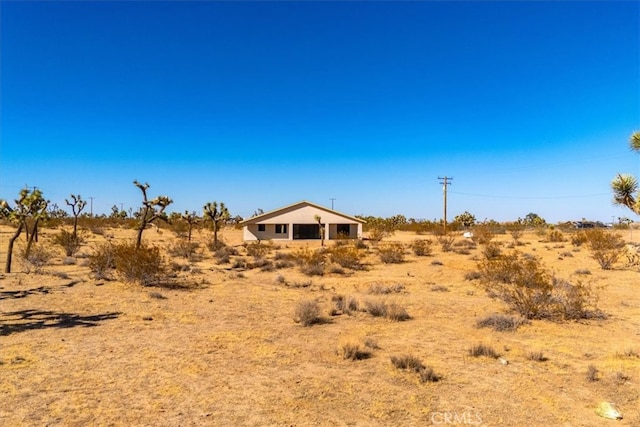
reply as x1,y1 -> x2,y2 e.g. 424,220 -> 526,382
113,242 -> 164,286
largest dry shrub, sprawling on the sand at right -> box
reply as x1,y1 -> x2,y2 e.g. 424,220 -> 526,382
480,252 -> 601,319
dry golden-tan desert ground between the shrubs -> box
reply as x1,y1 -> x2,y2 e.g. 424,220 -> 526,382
0,227 -> 640,426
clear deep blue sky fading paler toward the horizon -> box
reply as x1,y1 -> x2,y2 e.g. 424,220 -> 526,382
0,1 -> 640,222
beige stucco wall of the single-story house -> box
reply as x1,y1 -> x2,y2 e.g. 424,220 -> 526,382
242,206 -> 362,240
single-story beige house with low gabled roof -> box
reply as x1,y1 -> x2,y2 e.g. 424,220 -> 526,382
240,200 -> 366,241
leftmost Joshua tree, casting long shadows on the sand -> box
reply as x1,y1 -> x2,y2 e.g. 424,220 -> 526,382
0,188 -> 49,273
